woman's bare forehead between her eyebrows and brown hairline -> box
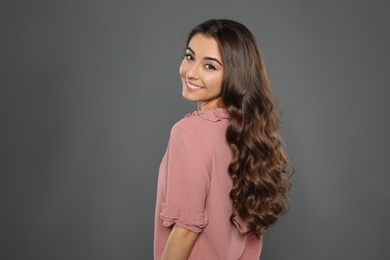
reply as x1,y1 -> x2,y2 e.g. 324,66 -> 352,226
188,34 -> 221,58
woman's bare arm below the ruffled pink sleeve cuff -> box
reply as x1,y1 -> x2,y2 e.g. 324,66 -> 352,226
161,225 -> 199,260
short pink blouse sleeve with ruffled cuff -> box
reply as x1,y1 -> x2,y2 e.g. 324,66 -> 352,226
160,124 -> 211,233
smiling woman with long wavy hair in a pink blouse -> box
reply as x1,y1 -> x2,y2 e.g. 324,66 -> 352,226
154,19 -> 290,260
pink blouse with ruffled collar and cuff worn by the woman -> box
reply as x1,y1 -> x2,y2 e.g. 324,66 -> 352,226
154,108 -> 262,260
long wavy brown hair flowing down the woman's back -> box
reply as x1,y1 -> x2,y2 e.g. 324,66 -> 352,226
187,19 -> 291,238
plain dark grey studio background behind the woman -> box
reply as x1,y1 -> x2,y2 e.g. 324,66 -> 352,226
0,0 -> 390,260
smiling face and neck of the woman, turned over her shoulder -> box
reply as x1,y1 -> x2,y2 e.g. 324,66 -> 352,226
180,34 -> 224,109
